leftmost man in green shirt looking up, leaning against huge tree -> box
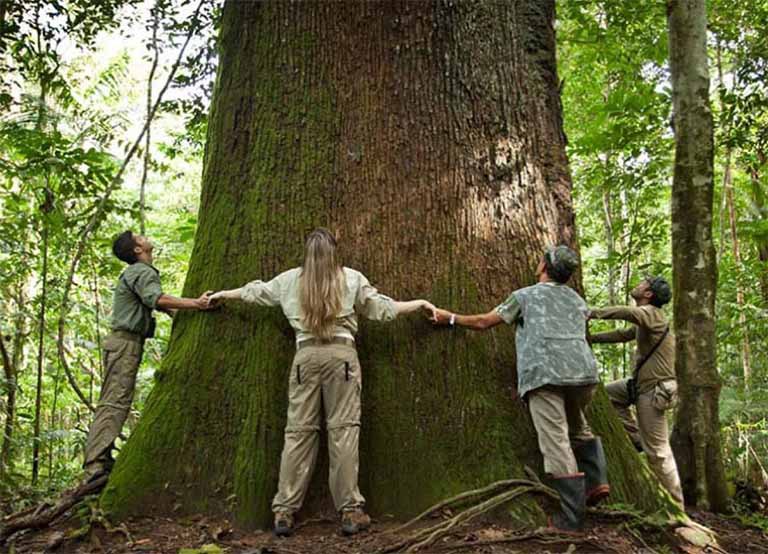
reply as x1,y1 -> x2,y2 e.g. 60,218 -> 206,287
83,231 -> 210,481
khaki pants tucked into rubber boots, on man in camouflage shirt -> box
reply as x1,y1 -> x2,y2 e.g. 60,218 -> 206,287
526,385 -> 595,477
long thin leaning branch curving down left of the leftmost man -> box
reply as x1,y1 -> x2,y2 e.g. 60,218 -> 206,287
56,0 -> 205,409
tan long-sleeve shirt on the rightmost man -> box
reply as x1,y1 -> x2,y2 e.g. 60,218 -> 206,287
590,304 -> 675,392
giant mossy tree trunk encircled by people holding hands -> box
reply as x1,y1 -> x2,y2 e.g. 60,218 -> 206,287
103,0 -> 680,525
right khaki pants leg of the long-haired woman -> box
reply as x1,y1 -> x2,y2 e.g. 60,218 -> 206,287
323,345 -> 365,511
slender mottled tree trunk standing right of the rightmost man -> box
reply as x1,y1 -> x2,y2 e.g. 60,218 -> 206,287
667,0 -> 728,510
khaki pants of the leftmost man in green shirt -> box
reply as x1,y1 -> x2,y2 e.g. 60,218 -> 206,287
83,331 -> 144,479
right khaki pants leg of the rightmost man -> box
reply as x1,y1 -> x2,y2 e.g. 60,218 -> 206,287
637,391 -> 683,506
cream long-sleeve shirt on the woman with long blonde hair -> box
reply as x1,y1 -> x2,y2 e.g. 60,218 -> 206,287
241,267 -> 397,343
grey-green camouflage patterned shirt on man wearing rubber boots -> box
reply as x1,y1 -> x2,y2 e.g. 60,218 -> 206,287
496,282 -> 598,396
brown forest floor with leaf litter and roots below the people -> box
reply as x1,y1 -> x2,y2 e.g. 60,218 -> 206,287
6,506 -> 768,554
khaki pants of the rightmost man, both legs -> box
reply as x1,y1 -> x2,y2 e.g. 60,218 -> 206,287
605,379 -> 683,506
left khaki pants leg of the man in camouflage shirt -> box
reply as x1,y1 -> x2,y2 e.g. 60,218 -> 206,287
528,387 -> 579,477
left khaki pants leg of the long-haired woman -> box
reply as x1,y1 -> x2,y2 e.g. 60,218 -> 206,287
272,349 -> 322,513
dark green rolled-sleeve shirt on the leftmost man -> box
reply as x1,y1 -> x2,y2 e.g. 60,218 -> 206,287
112,262 -> 163,337
